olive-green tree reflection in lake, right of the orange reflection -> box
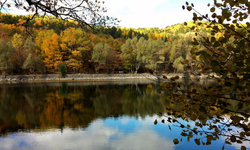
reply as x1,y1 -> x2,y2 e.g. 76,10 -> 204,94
91,85 -> 164,118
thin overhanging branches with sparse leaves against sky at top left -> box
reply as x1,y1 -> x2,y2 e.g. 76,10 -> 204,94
0,0 -> 117,28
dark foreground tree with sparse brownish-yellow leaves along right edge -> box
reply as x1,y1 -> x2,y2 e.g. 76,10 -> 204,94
152,0 -> 250,150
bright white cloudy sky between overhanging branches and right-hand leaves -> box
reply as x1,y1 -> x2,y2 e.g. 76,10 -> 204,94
105,0 -> 213,28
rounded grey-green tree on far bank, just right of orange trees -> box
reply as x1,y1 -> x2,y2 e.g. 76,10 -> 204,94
92,43 -> 110,73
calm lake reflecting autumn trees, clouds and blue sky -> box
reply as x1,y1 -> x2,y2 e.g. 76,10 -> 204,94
0,80 -> 246,150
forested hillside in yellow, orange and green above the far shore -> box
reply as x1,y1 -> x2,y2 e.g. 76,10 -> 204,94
0,13 -> 230,75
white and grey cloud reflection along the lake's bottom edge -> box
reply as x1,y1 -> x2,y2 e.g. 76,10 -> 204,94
0,118 -> 174,150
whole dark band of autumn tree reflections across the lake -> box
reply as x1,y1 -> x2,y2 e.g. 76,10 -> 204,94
0,83 -> 164,134
